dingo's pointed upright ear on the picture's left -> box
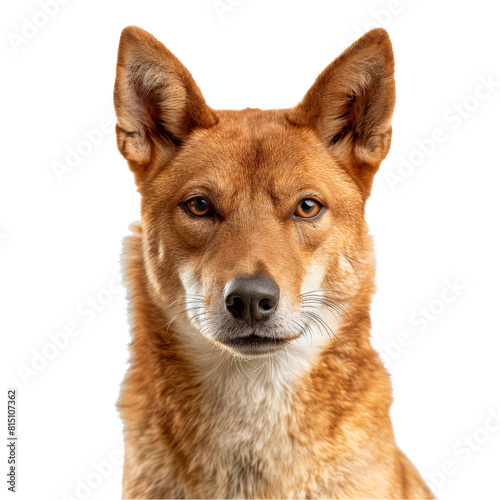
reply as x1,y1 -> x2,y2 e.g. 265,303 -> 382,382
114,26 -> 217,183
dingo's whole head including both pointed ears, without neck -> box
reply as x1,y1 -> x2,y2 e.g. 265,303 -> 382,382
114,27 -> 395,357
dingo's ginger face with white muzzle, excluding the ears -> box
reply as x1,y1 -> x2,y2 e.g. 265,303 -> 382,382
139,111 -> 363,355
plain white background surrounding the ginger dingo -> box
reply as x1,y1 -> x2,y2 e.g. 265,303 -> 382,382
0,0 -> 500,500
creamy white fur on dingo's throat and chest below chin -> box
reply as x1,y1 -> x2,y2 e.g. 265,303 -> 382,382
176,331 -> 328,498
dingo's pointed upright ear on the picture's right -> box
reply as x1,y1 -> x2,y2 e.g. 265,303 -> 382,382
288,28 -> 396,198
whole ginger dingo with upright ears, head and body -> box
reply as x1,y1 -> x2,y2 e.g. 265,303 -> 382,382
114,27 -> 432,498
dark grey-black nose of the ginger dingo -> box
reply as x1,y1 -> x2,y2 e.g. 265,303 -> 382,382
224,276 -> 280,326
